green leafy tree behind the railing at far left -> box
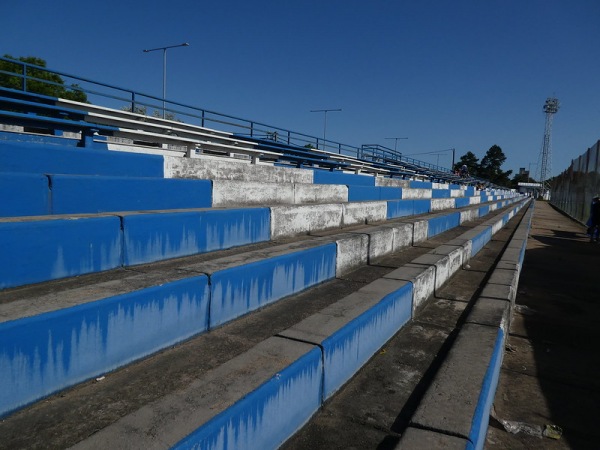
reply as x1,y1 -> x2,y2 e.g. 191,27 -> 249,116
0,55 -> 87,102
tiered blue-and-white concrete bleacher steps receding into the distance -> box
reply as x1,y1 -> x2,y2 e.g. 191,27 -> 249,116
0,89 -> 525,448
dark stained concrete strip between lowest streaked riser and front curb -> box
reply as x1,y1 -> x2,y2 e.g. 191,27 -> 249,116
282,215 -> 510,450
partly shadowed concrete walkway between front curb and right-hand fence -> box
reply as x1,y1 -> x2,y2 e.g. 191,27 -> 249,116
485,202 -> 600,450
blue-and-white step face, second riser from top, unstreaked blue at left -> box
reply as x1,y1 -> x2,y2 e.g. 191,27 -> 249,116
0,167 -> 508,218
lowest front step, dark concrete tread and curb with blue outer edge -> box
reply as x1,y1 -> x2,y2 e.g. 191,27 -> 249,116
282,200 -> 532,450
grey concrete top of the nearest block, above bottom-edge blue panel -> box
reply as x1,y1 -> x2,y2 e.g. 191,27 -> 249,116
72,337 -> 320,449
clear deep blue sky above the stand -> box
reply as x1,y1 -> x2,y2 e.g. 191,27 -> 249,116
0,0 -> 600,178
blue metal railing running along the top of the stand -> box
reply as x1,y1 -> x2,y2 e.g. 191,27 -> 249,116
0,57 -> 451,173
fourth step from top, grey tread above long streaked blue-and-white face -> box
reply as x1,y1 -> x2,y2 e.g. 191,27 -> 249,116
0,200 -> 520,413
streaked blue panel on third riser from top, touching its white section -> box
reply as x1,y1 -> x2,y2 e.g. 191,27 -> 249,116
123,208 -> 271,266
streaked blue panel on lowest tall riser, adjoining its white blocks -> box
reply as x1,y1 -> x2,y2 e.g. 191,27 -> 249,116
322,283 -> 413,400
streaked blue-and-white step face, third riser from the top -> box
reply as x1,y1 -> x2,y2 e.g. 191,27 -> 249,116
0,185 -> 517,289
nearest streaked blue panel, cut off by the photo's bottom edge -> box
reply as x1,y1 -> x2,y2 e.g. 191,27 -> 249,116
172,347 -> 323,450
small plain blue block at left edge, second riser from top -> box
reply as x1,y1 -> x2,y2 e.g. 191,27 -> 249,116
0,171 -> 50,217
